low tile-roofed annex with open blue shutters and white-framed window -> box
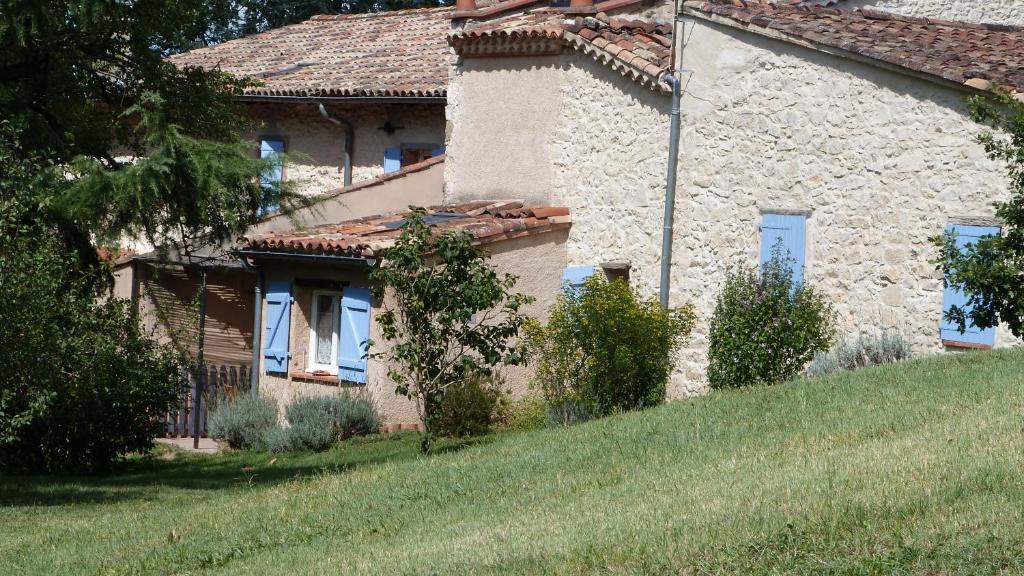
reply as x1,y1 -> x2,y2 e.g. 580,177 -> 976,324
241,201 -> 571,429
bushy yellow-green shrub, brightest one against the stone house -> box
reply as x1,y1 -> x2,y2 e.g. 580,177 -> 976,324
525,276 -> 694,416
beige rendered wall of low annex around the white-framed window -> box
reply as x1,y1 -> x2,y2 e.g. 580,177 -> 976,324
250,231 -> 566,425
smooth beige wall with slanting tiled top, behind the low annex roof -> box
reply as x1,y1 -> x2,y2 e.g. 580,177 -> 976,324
249,155 -> 444,234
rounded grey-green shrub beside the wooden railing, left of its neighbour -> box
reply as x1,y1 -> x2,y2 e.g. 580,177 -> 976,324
208,395 -> 278,450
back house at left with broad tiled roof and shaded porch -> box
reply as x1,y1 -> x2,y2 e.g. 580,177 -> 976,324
115,8 -> 452,366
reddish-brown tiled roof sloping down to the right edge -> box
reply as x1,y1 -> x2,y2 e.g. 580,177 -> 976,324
684,0 -> 1024,93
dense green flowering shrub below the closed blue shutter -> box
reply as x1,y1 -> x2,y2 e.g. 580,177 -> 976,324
708,245 -> 836,388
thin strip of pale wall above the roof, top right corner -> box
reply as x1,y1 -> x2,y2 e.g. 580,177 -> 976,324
839,0 -> 1024,26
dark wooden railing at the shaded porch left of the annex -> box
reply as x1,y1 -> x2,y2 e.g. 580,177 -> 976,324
161,365 -> 250,438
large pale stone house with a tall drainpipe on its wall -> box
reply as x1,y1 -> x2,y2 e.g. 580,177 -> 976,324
444,0 -> 1024,397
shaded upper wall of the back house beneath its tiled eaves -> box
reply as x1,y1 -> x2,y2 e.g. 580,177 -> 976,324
245,102 -> 444,194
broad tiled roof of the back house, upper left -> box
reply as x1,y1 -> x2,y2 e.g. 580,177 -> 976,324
169,7 -> 453,97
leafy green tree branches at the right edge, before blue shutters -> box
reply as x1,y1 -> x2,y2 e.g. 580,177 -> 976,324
933,89 -> 1024,336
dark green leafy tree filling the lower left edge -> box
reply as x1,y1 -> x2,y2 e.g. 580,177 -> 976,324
0,123 -> 183,471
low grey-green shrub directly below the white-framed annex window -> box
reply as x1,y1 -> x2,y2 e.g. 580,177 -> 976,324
267,394 -> 380,453
